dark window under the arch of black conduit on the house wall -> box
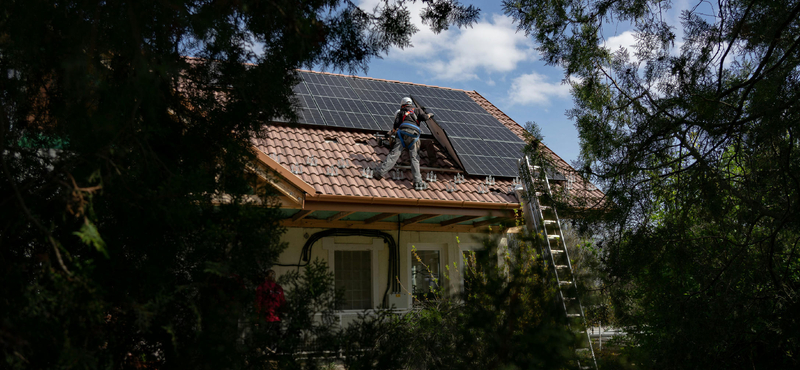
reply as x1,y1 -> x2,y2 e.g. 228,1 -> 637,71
333,250 -> 372,310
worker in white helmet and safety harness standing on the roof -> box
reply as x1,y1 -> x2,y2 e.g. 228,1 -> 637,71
373,97 -> 433,187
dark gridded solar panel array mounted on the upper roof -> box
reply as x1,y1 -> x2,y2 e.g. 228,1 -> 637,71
294,72 -> 525,177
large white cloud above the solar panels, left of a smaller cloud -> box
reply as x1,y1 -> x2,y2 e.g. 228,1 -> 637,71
359,0 -> 536,80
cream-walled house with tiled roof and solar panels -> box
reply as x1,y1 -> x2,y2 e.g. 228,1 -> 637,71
253,71 -> 602,320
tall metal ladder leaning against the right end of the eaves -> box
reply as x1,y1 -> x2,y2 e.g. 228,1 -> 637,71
517,156 -> 597,369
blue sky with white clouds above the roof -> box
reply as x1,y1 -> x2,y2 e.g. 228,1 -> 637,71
302,0 -> 688,163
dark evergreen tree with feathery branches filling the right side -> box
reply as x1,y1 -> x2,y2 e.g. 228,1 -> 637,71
504,0 -> 800,369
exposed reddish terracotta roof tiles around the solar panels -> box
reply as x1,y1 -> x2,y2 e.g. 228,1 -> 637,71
254,71 -> 604,204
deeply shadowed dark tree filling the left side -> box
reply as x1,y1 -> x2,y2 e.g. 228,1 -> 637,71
0,0 -> 478,369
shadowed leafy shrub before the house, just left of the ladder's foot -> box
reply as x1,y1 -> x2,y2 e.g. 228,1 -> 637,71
403,239 -> 577,369
